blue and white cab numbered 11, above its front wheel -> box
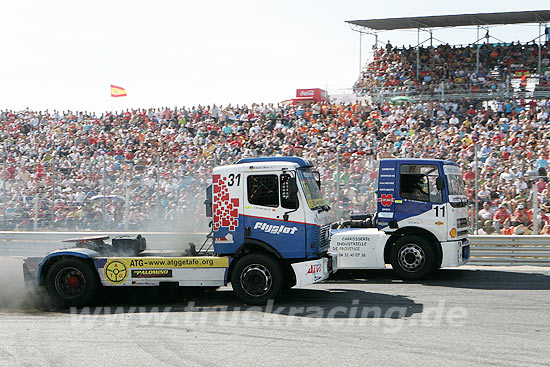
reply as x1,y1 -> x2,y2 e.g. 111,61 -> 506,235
377,159 -> 469,246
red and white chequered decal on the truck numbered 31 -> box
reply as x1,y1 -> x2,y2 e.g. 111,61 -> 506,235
212,175 -> 239,231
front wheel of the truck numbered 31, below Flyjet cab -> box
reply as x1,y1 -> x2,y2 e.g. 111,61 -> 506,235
231,254 -> 285,305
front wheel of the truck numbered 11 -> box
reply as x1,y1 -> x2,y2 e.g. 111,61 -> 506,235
390,236 -> 437,280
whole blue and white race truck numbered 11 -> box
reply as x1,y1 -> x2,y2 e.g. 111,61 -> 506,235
330,159 -> 470,279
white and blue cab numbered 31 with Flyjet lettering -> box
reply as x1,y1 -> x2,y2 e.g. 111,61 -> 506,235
211,157 -> 330,262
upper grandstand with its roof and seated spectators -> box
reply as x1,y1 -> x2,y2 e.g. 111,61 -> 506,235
348,10 -> 550,101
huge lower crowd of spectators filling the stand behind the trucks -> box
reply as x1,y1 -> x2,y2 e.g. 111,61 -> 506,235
0,96 -> 550,233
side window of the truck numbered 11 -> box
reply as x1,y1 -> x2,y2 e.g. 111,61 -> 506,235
399,164 -> 441,203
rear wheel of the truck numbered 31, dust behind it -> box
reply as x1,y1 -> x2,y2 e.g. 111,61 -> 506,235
46,259 -> 99,308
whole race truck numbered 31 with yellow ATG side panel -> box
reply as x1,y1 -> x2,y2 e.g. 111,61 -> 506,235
23,157 -> 335,307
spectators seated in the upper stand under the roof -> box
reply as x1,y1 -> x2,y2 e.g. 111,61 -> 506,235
355,41 -> 550,94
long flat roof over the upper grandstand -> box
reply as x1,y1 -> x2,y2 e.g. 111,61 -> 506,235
346,10 -> 550,31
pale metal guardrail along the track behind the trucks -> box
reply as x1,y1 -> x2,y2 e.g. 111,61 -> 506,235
0,232 -> 550,266
